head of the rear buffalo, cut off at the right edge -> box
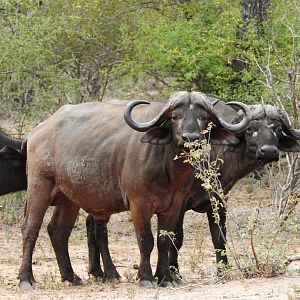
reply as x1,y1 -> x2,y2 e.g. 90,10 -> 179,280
240,105 -> 300,163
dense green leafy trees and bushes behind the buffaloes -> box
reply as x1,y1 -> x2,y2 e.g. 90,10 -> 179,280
0,0 -> 300,130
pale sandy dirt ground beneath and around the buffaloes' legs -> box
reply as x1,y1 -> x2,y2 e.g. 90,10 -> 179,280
0,179 -> 300,300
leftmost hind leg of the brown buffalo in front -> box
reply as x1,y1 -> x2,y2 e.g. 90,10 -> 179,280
18,178 -> 54,289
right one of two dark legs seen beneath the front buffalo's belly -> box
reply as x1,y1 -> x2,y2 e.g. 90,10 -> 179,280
93,218 -> 121,282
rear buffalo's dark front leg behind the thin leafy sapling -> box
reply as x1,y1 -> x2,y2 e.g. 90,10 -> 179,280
207,207 -> 228,265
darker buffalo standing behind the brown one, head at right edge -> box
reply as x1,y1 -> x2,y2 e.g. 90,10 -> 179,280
87,102 -> 300,280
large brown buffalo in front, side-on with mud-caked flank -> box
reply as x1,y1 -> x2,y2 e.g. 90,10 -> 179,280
19,92 -> 251,287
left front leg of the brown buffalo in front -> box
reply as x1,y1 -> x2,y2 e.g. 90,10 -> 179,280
131,203 -> 157,288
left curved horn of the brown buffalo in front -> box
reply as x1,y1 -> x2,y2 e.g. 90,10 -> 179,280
124,100 -> 169,132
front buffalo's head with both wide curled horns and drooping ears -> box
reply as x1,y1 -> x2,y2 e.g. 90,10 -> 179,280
124,91 -> 251,147
